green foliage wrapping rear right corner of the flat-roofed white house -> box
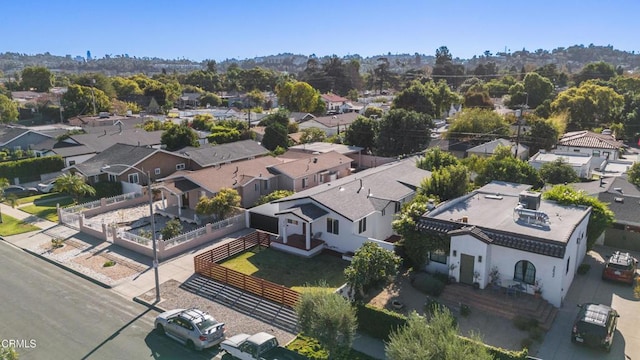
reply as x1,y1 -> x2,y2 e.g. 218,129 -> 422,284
542,185 -> 614,249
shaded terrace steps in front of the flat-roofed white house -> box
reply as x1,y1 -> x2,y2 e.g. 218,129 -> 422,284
438,284 -> 558,331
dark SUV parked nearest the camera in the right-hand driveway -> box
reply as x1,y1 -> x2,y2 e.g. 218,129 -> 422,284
571,303 -> 620,352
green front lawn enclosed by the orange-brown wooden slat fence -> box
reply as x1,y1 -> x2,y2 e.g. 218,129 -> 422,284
221,248 -> 349,291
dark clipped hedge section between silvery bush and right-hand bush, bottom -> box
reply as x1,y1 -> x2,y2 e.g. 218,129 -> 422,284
356,305 -> 407,340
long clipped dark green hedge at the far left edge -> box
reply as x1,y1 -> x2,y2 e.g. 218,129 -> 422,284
0,156 -> 64,184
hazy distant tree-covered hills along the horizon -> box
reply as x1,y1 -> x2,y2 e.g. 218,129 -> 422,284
0,44 -> 640,77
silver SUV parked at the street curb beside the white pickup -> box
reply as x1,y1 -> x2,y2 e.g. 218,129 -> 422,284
154,309 -> 225,350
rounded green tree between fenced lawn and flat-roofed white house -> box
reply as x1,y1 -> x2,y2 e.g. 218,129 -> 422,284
344,242 -> 401,298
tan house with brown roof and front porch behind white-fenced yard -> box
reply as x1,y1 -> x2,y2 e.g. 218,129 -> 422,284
160,156 -> 283,218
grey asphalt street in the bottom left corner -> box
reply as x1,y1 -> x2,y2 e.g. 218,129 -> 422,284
0,241 -> 221,360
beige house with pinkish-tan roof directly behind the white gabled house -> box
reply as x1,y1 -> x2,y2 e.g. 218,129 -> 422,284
269,151 -> 353,192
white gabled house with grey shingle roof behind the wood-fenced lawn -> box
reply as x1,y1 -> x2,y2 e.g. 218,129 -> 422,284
249,158 -> 431,256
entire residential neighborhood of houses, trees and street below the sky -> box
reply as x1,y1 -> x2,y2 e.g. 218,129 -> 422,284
0,25 -> 640,360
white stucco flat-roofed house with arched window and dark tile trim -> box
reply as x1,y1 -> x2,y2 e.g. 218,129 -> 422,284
418,181 -> 591,307
